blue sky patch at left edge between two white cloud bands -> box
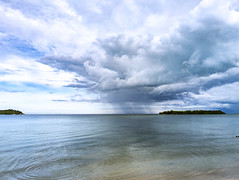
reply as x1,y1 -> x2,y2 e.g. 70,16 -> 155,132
0,35 -> 44,58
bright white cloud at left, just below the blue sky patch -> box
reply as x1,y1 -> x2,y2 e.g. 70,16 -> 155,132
0,56 -> 83,87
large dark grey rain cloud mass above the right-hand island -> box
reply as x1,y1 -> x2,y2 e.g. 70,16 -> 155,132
39,1 -> 239,112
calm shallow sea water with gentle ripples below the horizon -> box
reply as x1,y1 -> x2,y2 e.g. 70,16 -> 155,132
0,115 -> 239,180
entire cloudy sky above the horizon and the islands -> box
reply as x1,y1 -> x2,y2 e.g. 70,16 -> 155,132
0,0 -> 239,114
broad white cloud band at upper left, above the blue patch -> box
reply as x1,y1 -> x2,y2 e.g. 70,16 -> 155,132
0,0 -> 96,55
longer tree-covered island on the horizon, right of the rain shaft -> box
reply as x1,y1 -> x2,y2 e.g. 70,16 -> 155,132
159,110 -> 226,114
